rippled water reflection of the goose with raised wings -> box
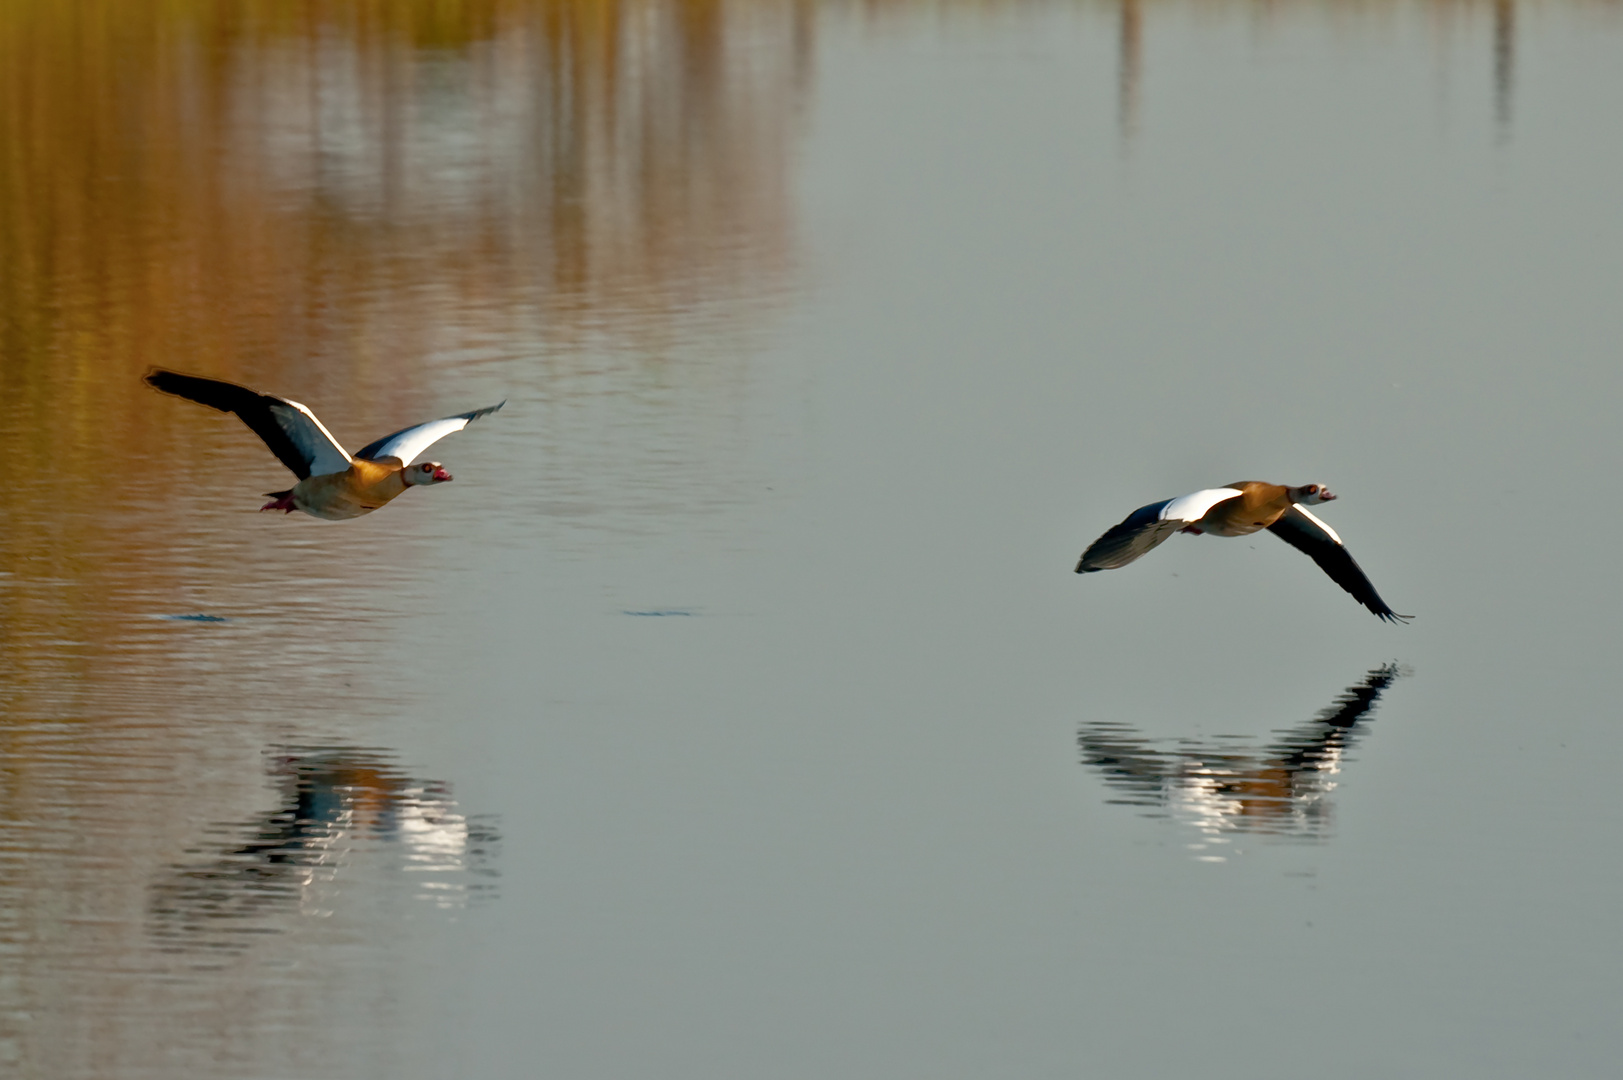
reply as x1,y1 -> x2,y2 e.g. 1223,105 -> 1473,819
149,747 -> 500,950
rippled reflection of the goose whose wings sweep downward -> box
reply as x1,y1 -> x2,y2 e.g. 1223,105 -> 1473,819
1078,663 -> 1409,862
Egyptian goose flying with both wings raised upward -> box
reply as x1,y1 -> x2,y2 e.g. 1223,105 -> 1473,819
146,367 -> 506,521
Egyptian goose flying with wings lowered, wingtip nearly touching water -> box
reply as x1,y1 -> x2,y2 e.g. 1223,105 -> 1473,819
1076,481 -> 1414,622
